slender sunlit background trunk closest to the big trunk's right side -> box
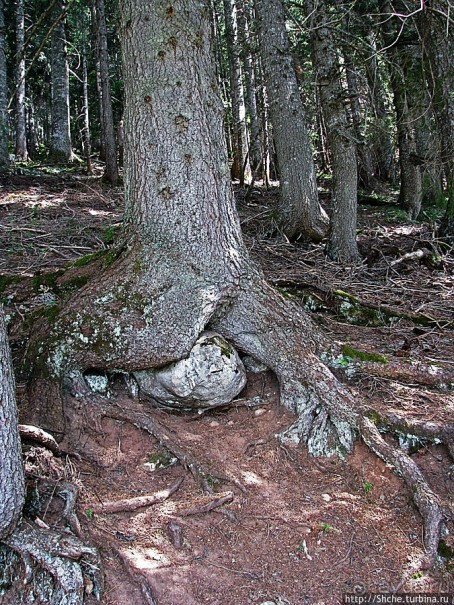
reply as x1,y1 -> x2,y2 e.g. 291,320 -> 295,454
224,0 -> 251,185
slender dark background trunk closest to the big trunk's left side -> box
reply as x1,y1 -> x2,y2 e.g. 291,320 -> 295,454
96,0 -> 118,185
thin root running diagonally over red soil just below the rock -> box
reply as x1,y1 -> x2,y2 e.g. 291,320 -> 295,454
94,397 -> 246,493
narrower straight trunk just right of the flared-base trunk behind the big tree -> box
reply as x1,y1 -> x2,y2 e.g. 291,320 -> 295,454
305,0 -> 359,263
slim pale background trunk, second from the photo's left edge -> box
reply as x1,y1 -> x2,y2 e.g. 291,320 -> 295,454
16,0 -> 28,161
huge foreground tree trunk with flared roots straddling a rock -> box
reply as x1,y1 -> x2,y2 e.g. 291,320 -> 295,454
27,0 -> 356,454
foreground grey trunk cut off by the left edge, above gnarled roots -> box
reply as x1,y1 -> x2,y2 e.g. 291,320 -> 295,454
0,305 -> 25,541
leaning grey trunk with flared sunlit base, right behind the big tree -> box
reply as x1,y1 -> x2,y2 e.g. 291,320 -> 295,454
255,0 -> 328,240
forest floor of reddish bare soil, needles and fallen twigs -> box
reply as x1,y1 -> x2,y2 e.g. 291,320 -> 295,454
0,169 -> 454,605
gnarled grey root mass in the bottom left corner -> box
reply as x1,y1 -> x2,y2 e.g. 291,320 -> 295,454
4,521 -> 103,605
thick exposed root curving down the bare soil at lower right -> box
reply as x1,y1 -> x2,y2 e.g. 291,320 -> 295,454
360,417 -> 445,569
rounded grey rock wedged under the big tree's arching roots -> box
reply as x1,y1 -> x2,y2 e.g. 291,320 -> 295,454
134,332 -> 246,409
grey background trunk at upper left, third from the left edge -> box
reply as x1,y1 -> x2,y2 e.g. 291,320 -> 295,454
49,0 -> 73,163
